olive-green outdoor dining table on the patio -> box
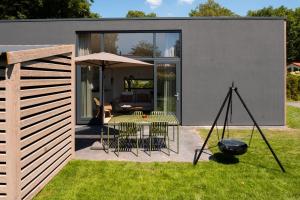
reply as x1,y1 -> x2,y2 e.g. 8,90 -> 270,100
101,114 -> 180,153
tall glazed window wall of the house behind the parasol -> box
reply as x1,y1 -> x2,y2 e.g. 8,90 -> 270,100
77,31 -> 181,123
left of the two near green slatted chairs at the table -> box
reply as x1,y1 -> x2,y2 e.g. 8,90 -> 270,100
117,122 -> 139,156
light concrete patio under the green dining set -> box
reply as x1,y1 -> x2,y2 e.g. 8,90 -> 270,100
75,126 -> 210,162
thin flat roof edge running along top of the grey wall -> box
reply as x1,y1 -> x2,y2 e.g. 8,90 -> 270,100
0,17 -> 286,23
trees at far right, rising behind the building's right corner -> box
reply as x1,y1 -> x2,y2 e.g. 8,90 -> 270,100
247,6 -> 300,62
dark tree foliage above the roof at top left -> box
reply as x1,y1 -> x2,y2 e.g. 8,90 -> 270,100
0,0 -> 100,19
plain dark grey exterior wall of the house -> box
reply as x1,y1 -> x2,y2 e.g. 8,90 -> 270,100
0,18 -> 285,125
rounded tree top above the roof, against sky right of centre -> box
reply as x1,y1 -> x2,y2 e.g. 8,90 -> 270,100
189,0 -> 237,17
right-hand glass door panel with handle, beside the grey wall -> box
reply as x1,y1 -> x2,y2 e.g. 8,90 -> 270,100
154,61 -> 181,119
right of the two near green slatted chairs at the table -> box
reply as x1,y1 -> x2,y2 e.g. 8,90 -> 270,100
149,122 -> 170,156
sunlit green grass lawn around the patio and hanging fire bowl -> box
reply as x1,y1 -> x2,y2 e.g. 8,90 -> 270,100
35,107 -> 300,200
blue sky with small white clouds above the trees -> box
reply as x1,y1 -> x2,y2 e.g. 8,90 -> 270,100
92,0 -> 300,17
